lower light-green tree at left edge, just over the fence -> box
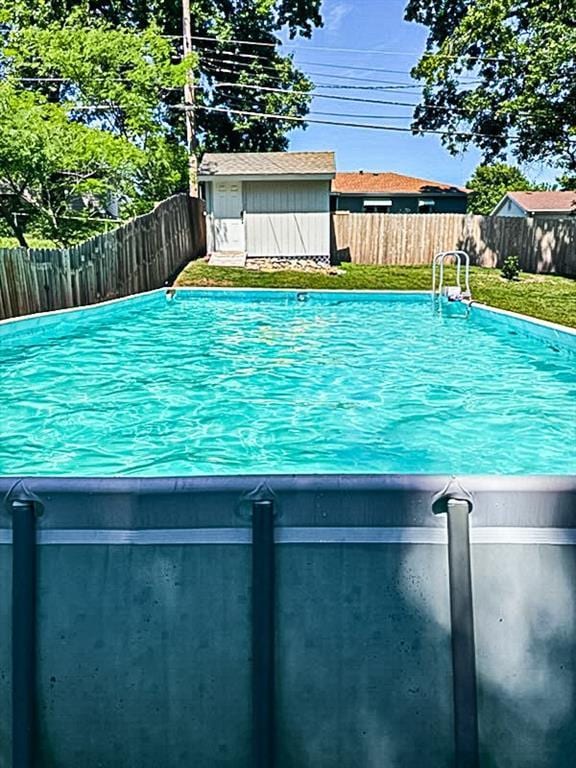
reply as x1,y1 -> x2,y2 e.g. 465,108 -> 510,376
0,83 -> 146,247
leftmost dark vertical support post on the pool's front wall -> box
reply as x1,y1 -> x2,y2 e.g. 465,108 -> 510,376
7,485 -> 37,768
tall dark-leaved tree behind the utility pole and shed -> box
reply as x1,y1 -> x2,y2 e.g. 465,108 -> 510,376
0,0 -> 322,153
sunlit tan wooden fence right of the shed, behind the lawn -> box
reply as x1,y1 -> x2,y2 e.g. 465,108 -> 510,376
332,213 -> 576,276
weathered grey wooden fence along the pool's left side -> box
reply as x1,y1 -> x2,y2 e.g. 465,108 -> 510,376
0,194 -> 206,318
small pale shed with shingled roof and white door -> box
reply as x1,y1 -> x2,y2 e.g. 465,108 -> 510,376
198,152 -> 335,264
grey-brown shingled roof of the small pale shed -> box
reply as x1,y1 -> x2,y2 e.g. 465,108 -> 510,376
198,152 -> 336,176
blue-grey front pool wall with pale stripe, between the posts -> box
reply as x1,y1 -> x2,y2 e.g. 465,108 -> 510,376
0,475 -> 576,768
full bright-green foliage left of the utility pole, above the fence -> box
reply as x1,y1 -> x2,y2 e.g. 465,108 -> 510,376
0,11 -> 194,243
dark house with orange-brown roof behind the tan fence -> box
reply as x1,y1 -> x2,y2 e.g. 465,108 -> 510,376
331,171 -> 468,213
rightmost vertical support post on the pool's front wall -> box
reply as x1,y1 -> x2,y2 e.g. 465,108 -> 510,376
432,480 -> 479,768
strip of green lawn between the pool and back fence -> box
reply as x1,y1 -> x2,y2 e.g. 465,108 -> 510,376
176,260 -> 576,328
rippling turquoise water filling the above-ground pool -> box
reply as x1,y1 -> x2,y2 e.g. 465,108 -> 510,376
0,291 -> 576,476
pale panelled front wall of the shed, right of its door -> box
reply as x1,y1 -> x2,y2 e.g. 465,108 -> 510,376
245,180 -> 330,257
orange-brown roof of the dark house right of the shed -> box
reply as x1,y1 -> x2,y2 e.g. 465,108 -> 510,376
332,171 -> 468,195
